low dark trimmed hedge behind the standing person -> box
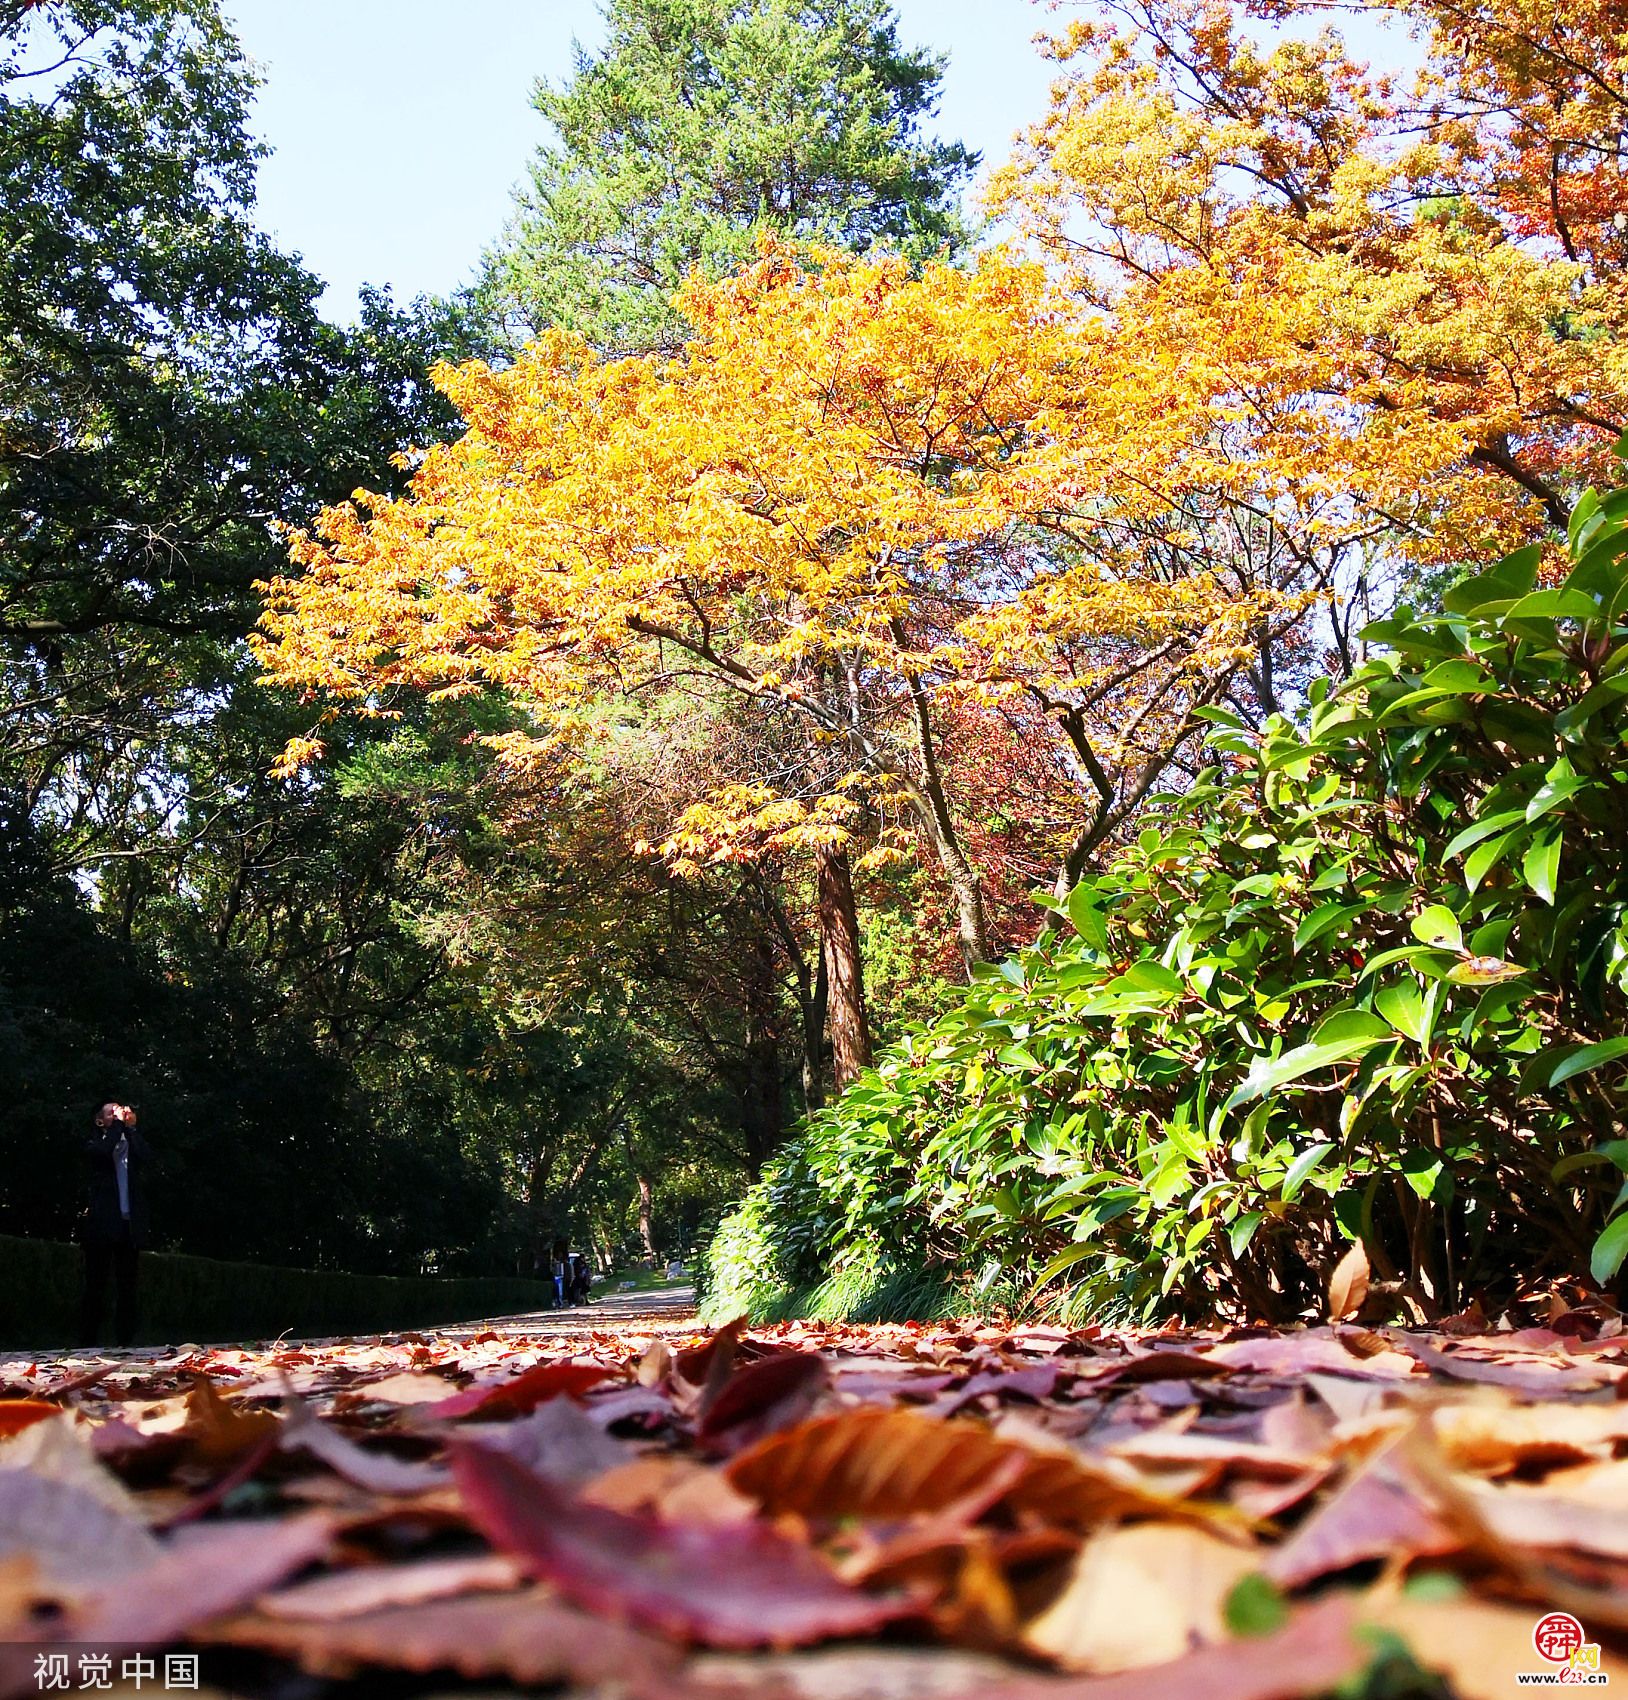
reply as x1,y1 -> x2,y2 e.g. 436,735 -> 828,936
0,1234 -> 554,1350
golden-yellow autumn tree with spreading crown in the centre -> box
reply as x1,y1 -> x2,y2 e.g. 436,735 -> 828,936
260,252 -> 1286,1060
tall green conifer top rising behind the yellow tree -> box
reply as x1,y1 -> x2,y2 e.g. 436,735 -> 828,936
483,0 -> 977,354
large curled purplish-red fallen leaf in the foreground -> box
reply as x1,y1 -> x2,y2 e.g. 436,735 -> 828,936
452,1443 -> 919,1647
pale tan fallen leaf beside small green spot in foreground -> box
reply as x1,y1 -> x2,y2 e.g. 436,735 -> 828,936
1023,1523 -> 1263,1671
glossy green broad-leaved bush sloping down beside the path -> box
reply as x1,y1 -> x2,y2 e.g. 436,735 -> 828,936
707,469 -> 1628,1321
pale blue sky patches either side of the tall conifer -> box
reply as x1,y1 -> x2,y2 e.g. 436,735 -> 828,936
226,0 -> 1055,320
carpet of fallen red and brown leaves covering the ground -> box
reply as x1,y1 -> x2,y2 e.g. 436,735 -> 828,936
0,1292 -> 1628,1700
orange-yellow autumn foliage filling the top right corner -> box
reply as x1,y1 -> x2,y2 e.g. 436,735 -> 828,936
992,0 -> 1628,563
